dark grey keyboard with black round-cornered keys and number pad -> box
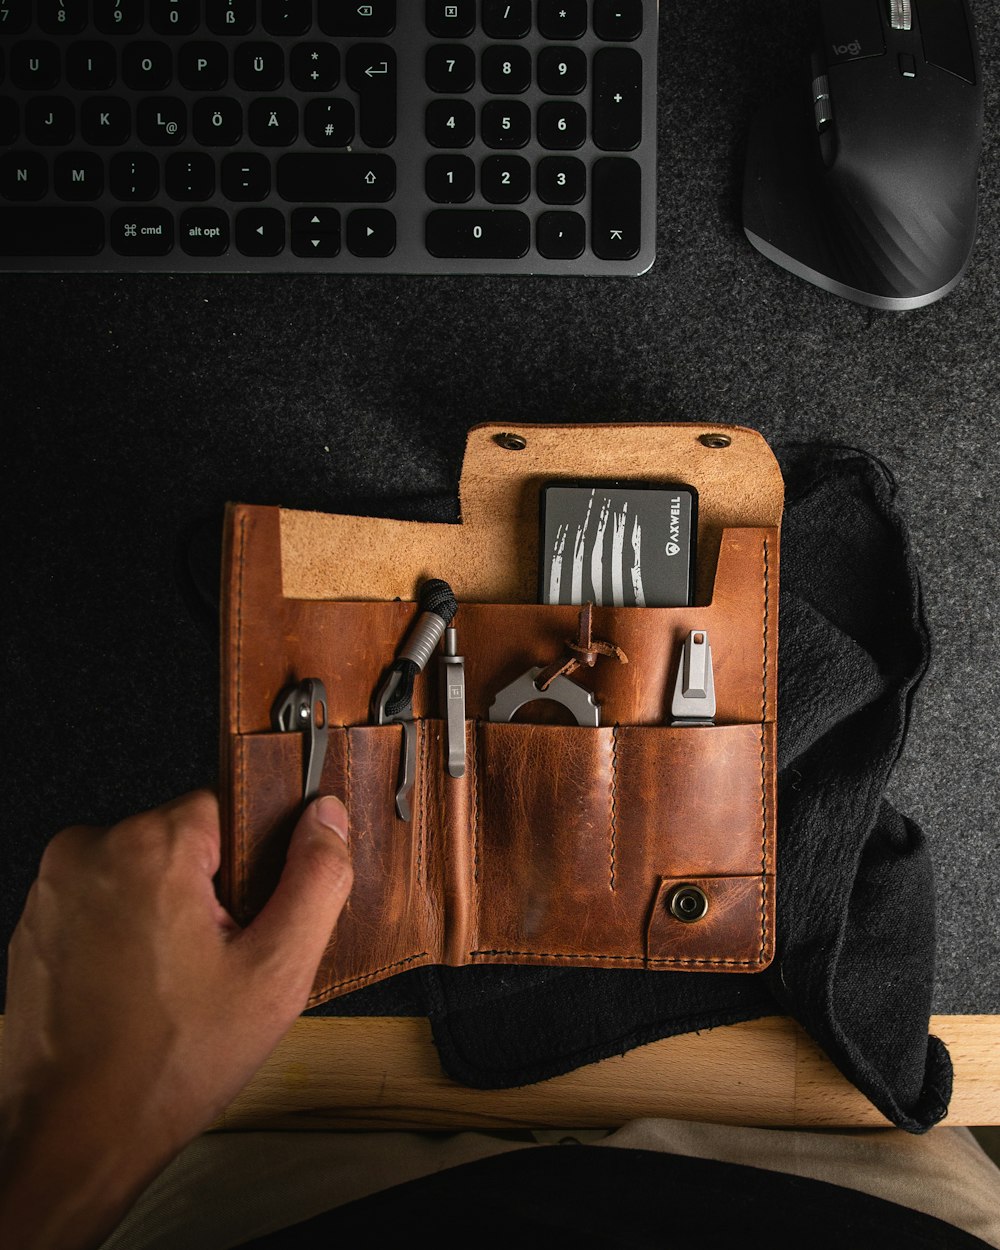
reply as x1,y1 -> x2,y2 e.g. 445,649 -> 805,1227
0,0 -> 658,275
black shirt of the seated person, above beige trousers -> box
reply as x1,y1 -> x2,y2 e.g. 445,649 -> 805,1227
235,1145 -> 988,1250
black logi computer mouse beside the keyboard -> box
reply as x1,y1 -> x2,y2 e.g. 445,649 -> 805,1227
743,0 -> 983,309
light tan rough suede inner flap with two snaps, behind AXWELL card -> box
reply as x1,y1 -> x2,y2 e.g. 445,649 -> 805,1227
280,423 -> 784,603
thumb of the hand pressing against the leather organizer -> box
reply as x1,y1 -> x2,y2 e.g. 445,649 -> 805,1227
243,795 -> 354,980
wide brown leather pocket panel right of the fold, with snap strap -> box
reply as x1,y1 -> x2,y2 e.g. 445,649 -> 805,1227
470,723 -> 774,970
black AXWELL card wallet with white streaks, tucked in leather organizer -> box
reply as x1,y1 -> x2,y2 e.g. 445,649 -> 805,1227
539,481 -> 698,608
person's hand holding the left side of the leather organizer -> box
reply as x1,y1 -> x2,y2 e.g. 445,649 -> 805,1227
0,790 -> 353,1250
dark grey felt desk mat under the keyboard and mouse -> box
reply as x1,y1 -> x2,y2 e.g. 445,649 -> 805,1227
0,0 -> 1000,1013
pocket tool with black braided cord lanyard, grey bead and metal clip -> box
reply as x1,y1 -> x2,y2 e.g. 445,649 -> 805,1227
375,578 -> 465,820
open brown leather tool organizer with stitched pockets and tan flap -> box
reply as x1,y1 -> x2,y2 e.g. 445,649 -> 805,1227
220,424 -> 783,1005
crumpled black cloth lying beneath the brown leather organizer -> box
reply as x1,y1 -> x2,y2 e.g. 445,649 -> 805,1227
305,446 -> 951,1133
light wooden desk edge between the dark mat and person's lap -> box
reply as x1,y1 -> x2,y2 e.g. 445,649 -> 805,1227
216,1015 -> 1000,1129
